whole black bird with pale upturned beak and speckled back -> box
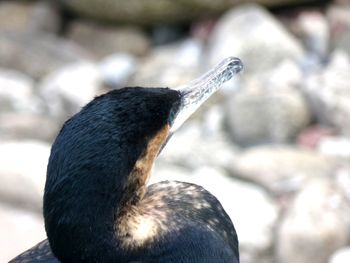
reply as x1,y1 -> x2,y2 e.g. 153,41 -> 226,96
10,57 -> 243,263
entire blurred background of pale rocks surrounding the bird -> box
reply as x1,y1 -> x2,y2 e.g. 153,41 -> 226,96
0,0 -> 350,263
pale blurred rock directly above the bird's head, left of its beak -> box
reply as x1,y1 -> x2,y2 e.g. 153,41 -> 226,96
131,39 -> 205,88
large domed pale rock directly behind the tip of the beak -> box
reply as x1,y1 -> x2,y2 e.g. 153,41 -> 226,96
207,4 -> 304,75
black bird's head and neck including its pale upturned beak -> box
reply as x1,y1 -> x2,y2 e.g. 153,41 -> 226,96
44,58 -> 242,258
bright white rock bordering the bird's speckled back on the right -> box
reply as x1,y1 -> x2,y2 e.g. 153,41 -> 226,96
150,165 -> 278,262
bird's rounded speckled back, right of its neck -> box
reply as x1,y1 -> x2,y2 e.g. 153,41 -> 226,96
130,181 -> 239,263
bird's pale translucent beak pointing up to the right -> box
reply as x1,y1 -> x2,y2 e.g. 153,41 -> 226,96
170,57 -> 243,132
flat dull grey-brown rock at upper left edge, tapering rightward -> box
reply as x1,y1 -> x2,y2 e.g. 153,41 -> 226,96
0,32 -> 89,79
